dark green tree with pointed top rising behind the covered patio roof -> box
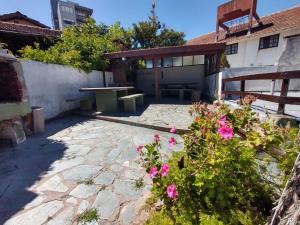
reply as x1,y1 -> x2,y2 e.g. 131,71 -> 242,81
133,0 -> 185,48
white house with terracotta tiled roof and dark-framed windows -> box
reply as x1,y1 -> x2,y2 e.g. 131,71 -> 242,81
187,5 -> 300,68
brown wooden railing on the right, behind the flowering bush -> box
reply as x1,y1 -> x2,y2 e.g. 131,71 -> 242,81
222,71 -> 300,114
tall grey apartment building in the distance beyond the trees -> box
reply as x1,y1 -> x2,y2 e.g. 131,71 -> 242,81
51,0 -> 93,30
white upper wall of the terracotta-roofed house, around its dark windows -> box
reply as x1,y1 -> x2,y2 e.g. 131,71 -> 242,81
227,29 -> 300,68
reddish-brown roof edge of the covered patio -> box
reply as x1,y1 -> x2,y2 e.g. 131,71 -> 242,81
104,43 -> 226,59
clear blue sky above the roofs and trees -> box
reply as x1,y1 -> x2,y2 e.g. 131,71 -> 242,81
0,0 -> 300,40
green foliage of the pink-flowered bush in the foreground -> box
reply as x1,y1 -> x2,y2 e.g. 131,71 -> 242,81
141,96 -> 300,225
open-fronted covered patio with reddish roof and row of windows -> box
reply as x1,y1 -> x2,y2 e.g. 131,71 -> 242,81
105,43 -> 226,98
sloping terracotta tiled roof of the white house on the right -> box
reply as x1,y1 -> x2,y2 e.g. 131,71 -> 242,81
187,5 -> 300,45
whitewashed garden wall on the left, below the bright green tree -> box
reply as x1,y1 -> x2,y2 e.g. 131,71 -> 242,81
21,60 -> 113,119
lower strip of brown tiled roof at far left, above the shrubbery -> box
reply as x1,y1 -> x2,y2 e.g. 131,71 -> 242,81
0,21 -> 61,37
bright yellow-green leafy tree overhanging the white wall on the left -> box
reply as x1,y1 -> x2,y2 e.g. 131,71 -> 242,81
20,18 -> 131,72
